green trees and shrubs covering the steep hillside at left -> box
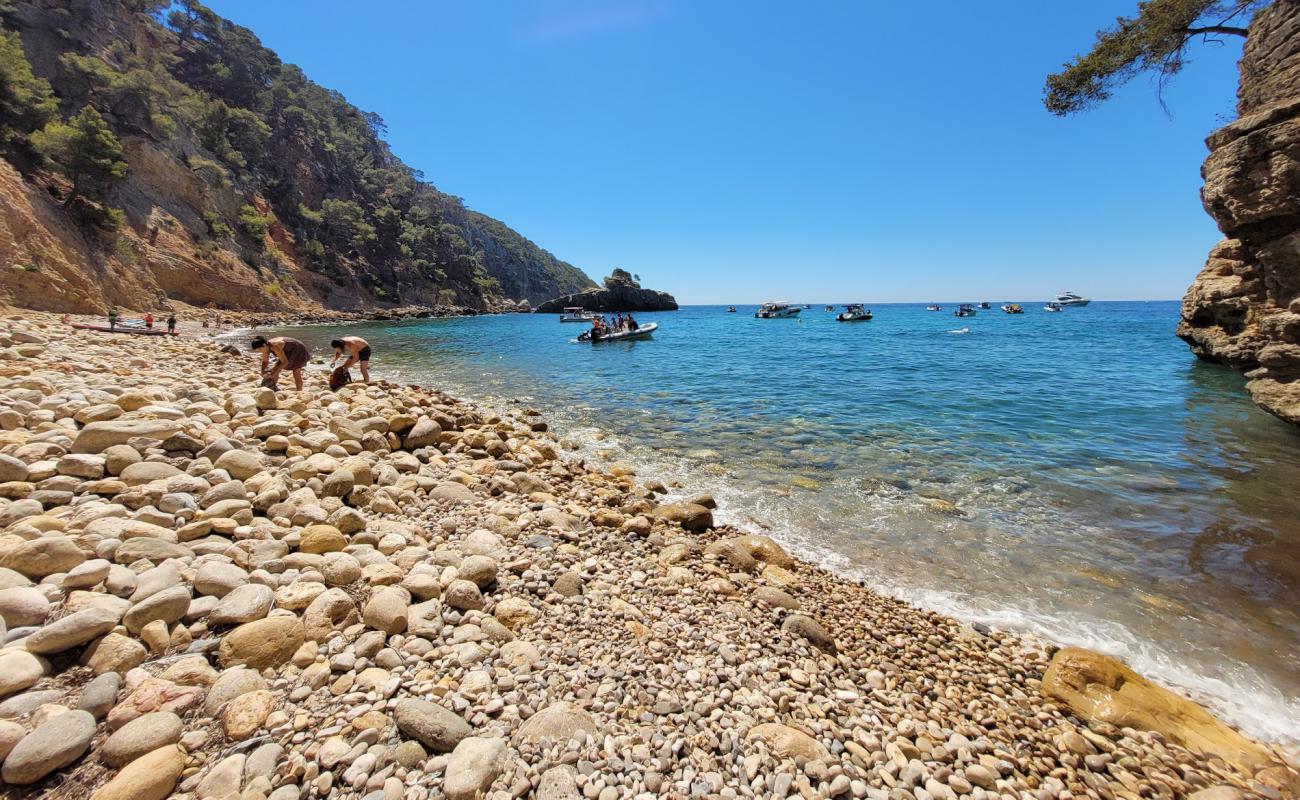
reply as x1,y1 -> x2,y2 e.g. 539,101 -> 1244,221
0,0 -> 593,308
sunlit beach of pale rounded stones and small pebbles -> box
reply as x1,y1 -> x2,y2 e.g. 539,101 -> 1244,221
0,313 -> 1284,800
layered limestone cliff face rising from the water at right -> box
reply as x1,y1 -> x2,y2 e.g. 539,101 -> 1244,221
1178,0 -> 1300,424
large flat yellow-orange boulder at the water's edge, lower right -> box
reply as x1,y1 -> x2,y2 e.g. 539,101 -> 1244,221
1043,648 -> 1275,774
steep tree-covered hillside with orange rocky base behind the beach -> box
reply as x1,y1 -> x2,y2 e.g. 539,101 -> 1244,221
0,0 -> 594,313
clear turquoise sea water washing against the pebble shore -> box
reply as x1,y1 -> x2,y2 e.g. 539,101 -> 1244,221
266,302 -> 1300,743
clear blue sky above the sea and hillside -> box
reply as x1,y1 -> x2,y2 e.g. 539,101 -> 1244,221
211,0 -> 1240,303
